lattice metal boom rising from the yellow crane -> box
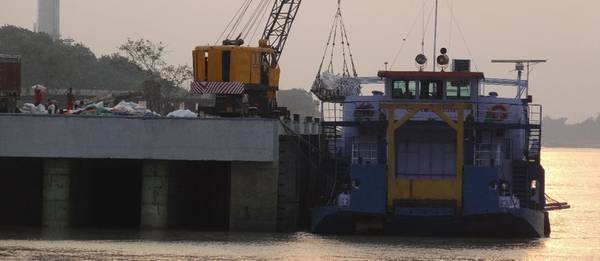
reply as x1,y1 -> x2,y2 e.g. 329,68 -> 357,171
262,0 -> 302,66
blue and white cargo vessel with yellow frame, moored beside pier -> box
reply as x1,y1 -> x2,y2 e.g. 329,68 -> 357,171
311,57 -> 566,238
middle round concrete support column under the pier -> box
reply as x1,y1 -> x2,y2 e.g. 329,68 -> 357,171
140,160 -> 169,229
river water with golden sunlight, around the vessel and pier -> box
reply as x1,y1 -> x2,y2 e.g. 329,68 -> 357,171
0,148 -> 600,260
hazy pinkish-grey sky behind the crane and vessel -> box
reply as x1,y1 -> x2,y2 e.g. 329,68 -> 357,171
0,0 -> 600,122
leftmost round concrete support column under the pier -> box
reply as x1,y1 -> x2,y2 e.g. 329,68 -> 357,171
42,159 -> 72,228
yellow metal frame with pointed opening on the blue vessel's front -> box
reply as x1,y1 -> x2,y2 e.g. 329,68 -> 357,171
383,103 -> 472,213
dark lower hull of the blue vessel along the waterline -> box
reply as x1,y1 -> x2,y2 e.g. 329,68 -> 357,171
311,207 -> 550,238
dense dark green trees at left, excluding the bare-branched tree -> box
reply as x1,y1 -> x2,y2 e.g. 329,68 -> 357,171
0,26 -> 149,90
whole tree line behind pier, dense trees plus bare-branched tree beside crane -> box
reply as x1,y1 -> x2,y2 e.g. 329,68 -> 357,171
0,25 -> 191,90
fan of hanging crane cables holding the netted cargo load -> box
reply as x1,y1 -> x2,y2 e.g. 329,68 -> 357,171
317,0 -> 358,78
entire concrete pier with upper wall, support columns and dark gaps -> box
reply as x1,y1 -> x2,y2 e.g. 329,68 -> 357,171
0,114 -> 318,232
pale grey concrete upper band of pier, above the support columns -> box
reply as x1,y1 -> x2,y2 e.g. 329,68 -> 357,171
0,114 -> 279,162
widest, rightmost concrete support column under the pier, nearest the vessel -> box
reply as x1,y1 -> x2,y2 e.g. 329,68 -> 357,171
229,162 -> 279,232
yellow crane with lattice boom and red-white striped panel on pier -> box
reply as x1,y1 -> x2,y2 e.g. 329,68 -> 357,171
192,0 -> 302,115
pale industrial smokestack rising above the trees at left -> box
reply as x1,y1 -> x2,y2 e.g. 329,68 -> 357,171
37,0 -> 60,40
